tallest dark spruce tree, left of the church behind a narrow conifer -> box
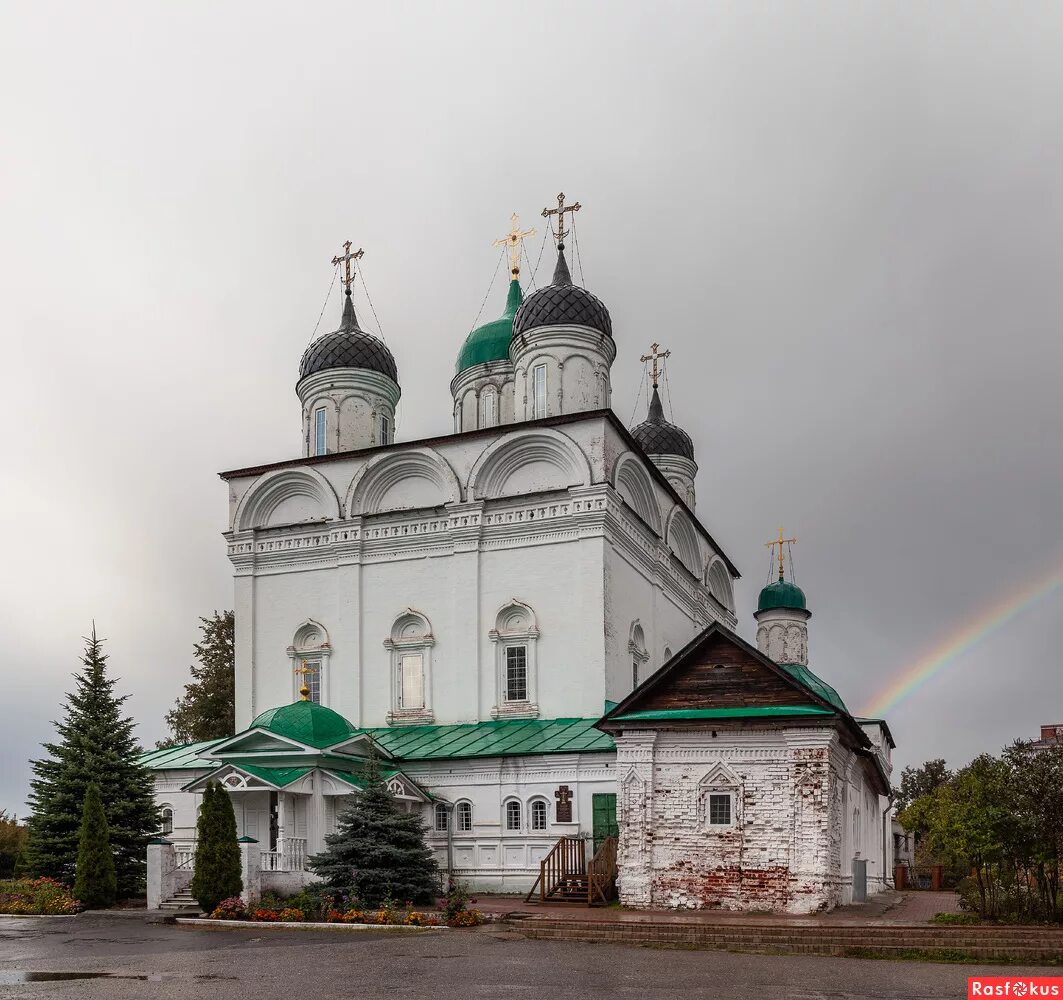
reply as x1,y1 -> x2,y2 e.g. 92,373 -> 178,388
27,625 -> 158,898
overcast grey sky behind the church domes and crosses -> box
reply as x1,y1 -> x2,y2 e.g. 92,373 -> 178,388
0,0 -> 1063,811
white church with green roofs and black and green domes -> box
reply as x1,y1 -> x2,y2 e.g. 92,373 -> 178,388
142,198 -> 893,913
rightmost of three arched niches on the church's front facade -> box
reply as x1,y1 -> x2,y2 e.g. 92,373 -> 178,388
469,427 -> 591,499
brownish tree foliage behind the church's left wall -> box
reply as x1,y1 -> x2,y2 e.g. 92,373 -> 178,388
157,611 -> 236,749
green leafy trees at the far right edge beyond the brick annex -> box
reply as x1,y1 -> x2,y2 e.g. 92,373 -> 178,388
898,742 -> 1063,919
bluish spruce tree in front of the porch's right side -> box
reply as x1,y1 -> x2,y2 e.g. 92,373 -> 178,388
307,755 -> 438,905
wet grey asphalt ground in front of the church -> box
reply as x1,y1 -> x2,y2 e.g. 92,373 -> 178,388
0,915 -> 1060,1000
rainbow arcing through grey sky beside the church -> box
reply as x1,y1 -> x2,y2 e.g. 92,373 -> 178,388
866,561 -> 1063,718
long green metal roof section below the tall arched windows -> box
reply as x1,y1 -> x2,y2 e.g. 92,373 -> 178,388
361,718 -> 614,761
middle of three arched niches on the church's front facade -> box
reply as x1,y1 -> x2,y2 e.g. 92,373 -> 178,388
345,448 -> 461,518
